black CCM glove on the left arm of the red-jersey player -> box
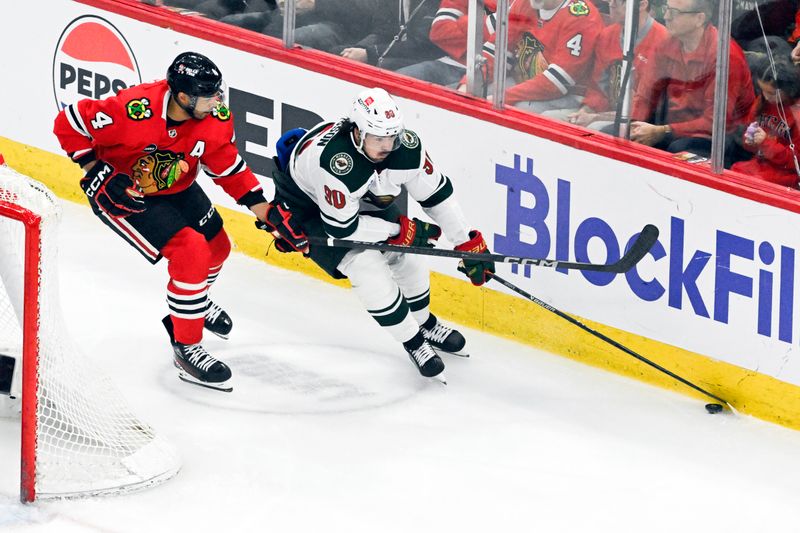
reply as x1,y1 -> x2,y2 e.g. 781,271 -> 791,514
81,159 -> 145,218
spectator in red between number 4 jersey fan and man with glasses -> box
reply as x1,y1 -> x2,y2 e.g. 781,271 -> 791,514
542,0 -> 669,130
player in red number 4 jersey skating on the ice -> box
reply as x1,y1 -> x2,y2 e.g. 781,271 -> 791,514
54,52 -> 306,391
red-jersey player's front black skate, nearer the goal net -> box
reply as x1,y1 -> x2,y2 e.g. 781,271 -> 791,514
162,315 -> 233,392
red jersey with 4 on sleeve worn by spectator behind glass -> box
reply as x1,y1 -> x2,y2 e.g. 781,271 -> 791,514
483,0 -> 603,105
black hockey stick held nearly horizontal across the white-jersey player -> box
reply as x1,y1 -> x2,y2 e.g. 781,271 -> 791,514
308,224 -> 658,274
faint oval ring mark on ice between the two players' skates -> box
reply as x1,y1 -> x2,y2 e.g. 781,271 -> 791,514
161,343 -> 441,414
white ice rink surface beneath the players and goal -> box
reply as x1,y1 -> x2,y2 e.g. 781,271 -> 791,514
0,198 -> 800,533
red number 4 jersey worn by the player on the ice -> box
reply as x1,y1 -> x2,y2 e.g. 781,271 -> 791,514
53,80 -> 261,200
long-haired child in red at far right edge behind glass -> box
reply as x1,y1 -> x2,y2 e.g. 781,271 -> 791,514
731,60 -> 800,188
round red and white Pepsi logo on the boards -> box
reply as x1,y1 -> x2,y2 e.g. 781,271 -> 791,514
53,15 -> 142,110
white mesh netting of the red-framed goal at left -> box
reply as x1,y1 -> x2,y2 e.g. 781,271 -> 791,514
0,166 -> 180,498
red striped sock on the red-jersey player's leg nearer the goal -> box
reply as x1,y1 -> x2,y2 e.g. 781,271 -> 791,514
161,228 -> 211,344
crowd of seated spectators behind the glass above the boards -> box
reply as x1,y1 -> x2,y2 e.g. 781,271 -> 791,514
143,0 -> 800,188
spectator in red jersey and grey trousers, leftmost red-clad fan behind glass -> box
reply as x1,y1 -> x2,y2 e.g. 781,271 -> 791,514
397,0 -> 497,85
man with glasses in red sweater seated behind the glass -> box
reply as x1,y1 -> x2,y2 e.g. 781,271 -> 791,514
631,0 -> 754,157
